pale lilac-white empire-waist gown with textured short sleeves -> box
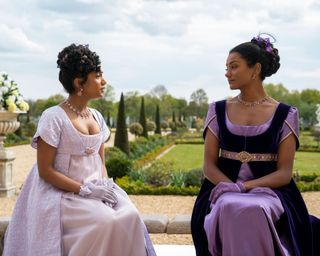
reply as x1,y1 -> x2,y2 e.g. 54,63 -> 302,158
3,106 -> 155,256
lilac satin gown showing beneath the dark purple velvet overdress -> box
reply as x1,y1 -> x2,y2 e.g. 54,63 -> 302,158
204,104 -> 298,256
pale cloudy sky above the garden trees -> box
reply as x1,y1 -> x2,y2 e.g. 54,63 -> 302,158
0,0 -> 320,101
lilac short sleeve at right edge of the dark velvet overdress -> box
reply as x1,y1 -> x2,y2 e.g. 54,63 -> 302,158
280,107 -> 299,146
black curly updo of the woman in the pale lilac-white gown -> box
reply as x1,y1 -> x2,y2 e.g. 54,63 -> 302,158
57,44 -> 101,94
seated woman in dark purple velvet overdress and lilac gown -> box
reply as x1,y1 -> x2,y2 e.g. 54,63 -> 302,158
191,35 -> 320,256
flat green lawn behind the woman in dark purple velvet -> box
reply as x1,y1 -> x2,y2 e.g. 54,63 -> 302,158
161,144 -> 320,176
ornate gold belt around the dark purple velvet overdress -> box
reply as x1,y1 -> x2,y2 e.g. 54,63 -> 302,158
220,149 -> 278,163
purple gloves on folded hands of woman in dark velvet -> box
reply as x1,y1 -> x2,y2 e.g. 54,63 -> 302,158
209,182 -> 246,204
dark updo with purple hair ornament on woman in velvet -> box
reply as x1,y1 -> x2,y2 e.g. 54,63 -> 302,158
229,35 -> 280,81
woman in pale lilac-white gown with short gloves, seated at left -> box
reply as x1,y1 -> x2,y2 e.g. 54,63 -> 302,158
3,44 -> 155,256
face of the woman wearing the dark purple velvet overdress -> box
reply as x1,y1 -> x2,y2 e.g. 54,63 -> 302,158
225,52 -> 254,90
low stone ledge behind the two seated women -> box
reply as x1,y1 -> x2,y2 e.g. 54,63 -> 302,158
0,214 -> 191,255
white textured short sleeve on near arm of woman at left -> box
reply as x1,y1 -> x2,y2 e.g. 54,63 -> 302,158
31,106 -> 63,149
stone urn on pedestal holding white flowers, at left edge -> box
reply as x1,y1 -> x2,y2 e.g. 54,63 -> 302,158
0,111 -> 25,197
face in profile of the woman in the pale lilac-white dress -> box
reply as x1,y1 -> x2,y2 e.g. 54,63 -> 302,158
83,71 -> 107,99
